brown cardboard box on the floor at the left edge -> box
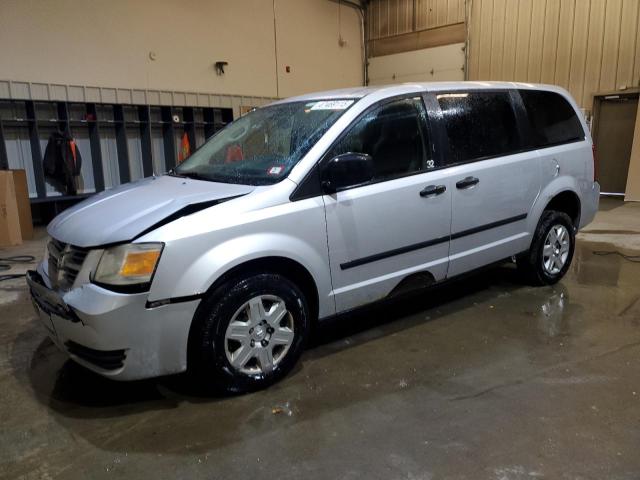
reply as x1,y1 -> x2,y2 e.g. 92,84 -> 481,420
0,170 -> 33,247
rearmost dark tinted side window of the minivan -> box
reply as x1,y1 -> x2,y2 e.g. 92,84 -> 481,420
520,90 -> 584,147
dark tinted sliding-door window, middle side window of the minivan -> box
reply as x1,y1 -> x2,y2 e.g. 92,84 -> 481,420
436,91 -> 523,163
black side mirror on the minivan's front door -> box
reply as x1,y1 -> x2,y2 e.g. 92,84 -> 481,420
321,152 -> 373,193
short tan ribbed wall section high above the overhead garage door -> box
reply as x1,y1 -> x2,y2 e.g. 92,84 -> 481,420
367,0 -> 465,40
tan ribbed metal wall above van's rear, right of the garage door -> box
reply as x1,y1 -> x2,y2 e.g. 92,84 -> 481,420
468,0 -> 640,110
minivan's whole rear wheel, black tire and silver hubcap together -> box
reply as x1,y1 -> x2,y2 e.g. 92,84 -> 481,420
517,210 -> 576,285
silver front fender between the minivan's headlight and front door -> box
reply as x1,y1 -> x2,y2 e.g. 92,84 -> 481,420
139,180 -> 335,317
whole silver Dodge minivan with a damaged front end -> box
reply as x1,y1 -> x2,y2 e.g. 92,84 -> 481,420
27,82 -> 599,391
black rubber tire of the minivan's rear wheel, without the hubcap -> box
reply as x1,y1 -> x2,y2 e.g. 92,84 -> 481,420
516,210 -> 576,285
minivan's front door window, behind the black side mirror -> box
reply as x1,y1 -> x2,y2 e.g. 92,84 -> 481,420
329,97 -> 434,181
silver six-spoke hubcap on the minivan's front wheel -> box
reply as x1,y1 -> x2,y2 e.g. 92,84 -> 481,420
224,295 -> 294,375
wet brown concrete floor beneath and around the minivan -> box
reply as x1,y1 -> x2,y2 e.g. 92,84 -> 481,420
0,232 -> 640,480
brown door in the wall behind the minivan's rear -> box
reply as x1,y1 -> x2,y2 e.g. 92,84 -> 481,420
594,95 -> 638,193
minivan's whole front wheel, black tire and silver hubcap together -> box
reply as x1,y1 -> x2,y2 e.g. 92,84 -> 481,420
189,273 -> 309,392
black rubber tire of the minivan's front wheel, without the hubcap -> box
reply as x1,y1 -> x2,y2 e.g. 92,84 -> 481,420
188,273 -> 310,393
